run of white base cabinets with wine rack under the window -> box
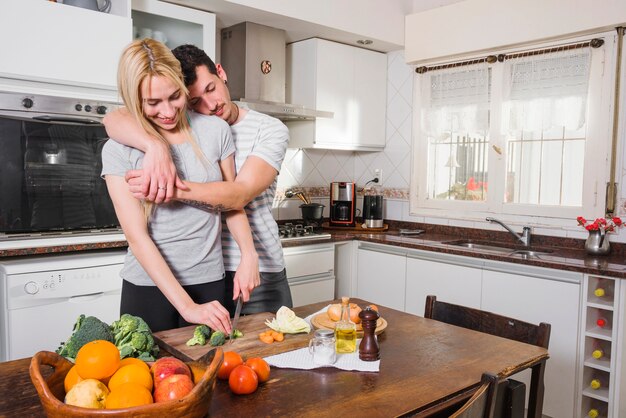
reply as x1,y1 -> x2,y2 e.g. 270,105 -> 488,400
348,242 -> 584,418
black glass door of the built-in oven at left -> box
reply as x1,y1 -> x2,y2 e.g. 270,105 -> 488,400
0,115 -> 119,234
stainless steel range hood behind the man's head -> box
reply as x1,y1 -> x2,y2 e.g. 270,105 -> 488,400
220,22 -> 333,121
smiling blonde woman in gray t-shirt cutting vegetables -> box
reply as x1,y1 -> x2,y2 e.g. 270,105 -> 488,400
102,39 -> 258,332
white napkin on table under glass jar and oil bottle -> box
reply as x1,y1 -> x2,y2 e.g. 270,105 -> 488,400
265,305 -> 380,372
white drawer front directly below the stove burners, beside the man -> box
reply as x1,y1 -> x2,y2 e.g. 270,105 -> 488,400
283,245 -> 335,278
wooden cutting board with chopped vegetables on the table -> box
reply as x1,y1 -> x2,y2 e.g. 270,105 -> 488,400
153,312 -> 313,361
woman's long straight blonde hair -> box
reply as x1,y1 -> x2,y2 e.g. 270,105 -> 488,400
117,39 -> 209,221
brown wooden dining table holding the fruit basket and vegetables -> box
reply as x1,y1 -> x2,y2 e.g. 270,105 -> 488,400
0,299 -> 548,417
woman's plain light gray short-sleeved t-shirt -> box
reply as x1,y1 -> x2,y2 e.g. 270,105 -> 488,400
102,112 -> 235,286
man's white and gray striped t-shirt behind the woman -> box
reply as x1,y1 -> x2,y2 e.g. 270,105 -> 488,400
222,110 -> 289,273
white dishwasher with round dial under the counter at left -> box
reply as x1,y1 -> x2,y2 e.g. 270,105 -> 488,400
0,250 -> 126,361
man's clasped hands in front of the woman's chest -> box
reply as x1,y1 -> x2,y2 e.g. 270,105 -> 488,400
126,141 -> 189,203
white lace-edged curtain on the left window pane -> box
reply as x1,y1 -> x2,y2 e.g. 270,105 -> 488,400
421,63 -> 489,140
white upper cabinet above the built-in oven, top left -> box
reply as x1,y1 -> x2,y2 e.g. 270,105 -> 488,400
0,0 -> 132,90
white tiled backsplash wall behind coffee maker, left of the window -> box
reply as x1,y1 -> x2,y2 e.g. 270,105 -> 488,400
274,51 -> 413,220
